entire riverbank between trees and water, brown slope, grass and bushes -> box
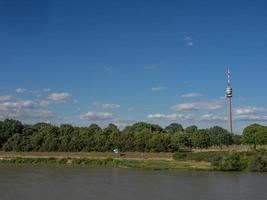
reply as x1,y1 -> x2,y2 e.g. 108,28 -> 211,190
0,149 -> 267,172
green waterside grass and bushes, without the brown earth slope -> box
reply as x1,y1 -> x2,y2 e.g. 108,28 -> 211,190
0,149 -> 267,172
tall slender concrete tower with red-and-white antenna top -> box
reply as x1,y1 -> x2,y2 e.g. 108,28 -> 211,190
226,67 -> 233,133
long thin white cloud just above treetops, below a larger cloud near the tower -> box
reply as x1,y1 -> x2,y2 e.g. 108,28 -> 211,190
147,113 -> 194,121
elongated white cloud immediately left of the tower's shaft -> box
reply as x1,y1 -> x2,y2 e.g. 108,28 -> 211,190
172,101 -> 222,111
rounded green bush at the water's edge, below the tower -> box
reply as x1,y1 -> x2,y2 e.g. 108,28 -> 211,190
217,152 -> 248,171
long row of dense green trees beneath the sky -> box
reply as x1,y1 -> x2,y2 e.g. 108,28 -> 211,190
0,119 -> 267,152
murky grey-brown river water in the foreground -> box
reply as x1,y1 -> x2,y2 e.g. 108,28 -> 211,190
0,165 -> 267,200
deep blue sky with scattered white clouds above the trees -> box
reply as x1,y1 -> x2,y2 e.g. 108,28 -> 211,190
0,0 -> 267,132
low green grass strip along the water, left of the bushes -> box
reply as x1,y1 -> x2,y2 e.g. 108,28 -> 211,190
0,157 -> 212,170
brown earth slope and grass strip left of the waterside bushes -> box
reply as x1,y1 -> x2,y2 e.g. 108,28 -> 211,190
0,152 -> 214,171
